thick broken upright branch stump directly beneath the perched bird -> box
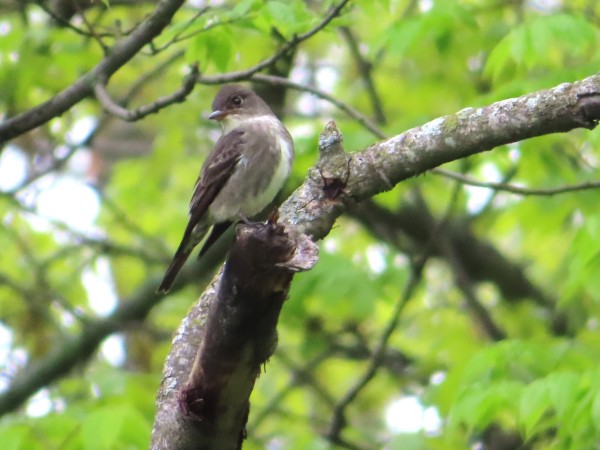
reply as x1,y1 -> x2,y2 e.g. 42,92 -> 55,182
151,223 -> 317,450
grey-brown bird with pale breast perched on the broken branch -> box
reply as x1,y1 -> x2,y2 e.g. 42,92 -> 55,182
157,84 -> 294,293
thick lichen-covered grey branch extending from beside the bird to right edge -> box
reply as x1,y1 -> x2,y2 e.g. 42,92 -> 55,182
280,75 -> 600,239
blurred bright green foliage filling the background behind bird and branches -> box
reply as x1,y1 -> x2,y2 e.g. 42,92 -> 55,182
0,0 -> 600,450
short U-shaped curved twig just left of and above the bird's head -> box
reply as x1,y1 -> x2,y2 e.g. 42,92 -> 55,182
94,64 -> 200,122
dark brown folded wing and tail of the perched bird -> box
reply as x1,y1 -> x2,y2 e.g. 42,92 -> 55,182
158,130 -> 246,292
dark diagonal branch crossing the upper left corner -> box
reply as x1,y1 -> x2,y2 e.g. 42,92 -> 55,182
0,0 -> 184,145
